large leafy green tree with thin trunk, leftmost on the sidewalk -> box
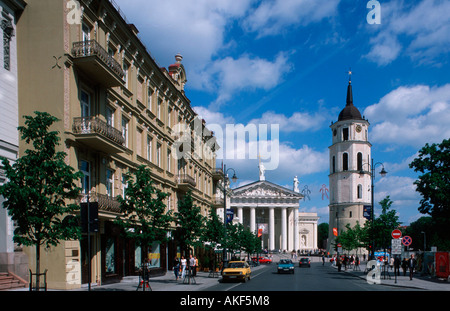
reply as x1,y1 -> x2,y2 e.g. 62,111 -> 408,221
0,111 -> 82,290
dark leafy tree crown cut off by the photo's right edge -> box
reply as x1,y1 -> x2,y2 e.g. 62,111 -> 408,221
409,139 -> 450,244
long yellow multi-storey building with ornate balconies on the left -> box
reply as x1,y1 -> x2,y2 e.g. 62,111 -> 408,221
17,0 -> 219,289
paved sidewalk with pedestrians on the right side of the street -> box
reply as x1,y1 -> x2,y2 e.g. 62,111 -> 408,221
328,263 -> 450,291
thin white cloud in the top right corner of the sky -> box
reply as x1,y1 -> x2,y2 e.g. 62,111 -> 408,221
366,0 -> 450,65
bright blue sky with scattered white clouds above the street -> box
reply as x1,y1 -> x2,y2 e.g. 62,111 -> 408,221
115,0 -> 450,224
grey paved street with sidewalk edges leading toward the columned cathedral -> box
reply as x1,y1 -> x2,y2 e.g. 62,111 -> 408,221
50,256 -> 450,292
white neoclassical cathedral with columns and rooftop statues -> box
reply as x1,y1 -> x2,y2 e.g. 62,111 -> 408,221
230,165 -> 319,252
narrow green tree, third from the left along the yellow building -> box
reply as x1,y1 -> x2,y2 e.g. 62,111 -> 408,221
175,191 -> 206,262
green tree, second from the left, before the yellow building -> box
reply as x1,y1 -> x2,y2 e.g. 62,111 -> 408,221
115,165 -> 173,268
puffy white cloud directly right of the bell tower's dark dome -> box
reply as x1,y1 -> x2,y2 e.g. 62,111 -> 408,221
364,84 -> 450,148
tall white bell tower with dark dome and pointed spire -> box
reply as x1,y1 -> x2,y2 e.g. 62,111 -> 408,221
327,72 -> 372,254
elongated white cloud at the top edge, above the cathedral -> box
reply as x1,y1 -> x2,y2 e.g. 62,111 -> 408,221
243,0 -> 339,37
